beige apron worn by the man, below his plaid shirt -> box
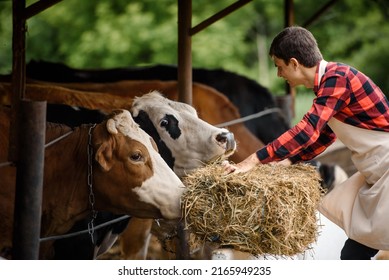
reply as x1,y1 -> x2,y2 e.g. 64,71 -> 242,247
319,118 -> 389,250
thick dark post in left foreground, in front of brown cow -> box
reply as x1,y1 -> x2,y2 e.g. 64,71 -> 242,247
12,101 -> 46,260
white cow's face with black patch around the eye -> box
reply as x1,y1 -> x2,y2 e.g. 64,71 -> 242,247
131,91 -> 236,177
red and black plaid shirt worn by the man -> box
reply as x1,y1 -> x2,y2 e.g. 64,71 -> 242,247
256,62 -> 389,163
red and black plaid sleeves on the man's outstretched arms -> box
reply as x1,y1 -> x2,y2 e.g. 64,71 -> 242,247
256,76 -> 348,163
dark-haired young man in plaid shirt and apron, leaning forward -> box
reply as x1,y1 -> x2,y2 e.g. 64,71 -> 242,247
224,26 -> 389,259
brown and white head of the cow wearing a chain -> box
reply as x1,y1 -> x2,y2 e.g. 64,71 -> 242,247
92,110 -> 184,219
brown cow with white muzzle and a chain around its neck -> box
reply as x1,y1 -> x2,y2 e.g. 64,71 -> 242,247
0,108 -> 185,258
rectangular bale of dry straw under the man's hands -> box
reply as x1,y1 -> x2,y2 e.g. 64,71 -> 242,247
182,163 -> 322,256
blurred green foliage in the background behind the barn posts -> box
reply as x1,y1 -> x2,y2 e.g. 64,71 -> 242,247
0,0 -> 389,94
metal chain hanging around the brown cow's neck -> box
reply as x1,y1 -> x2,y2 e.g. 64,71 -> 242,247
87,124 -> 97,244
